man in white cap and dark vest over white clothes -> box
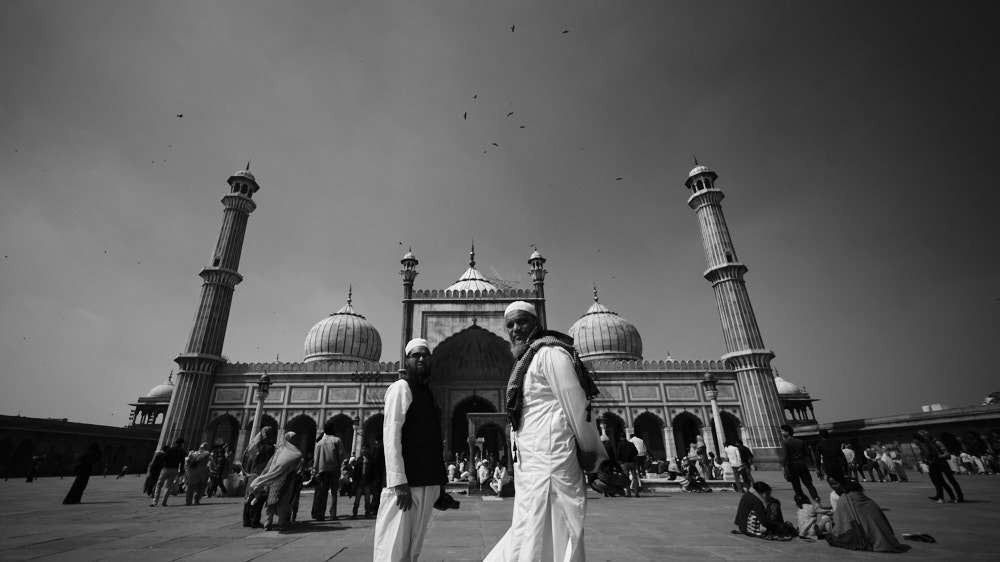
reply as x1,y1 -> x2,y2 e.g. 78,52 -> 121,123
374,338 -> 448,562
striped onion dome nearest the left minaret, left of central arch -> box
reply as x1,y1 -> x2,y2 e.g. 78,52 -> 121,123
305,293 -> 382,363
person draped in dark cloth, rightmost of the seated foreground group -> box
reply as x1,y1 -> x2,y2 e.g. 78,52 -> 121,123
826,478 -> 907,552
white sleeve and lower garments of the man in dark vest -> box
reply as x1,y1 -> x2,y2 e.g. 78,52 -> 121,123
374,379 -> 441,562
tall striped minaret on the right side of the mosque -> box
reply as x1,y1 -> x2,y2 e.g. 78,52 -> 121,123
684,160 -> 784,462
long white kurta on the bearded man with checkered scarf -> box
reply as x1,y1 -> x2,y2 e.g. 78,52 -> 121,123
486,346 -> 607,562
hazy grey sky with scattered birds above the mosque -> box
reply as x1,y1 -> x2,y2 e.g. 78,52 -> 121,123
0,0 -> 1000,425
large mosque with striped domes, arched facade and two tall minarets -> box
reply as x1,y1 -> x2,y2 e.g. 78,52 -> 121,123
152,165 -> 815,466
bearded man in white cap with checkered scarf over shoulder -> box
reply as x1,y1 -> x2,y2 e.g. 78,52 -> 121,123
486,301 -> 607,562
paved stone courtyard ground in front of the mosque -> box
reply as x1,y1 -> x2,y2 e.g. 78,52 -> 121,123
0,473 -> 1000,562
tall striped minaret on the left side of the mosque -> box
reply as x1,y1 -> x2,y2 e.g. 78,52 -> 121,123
160,162 -> 260,448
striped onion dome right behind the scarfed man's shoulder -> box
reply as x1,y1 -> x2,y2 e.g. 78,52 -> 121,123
569,289 -> 642,361
